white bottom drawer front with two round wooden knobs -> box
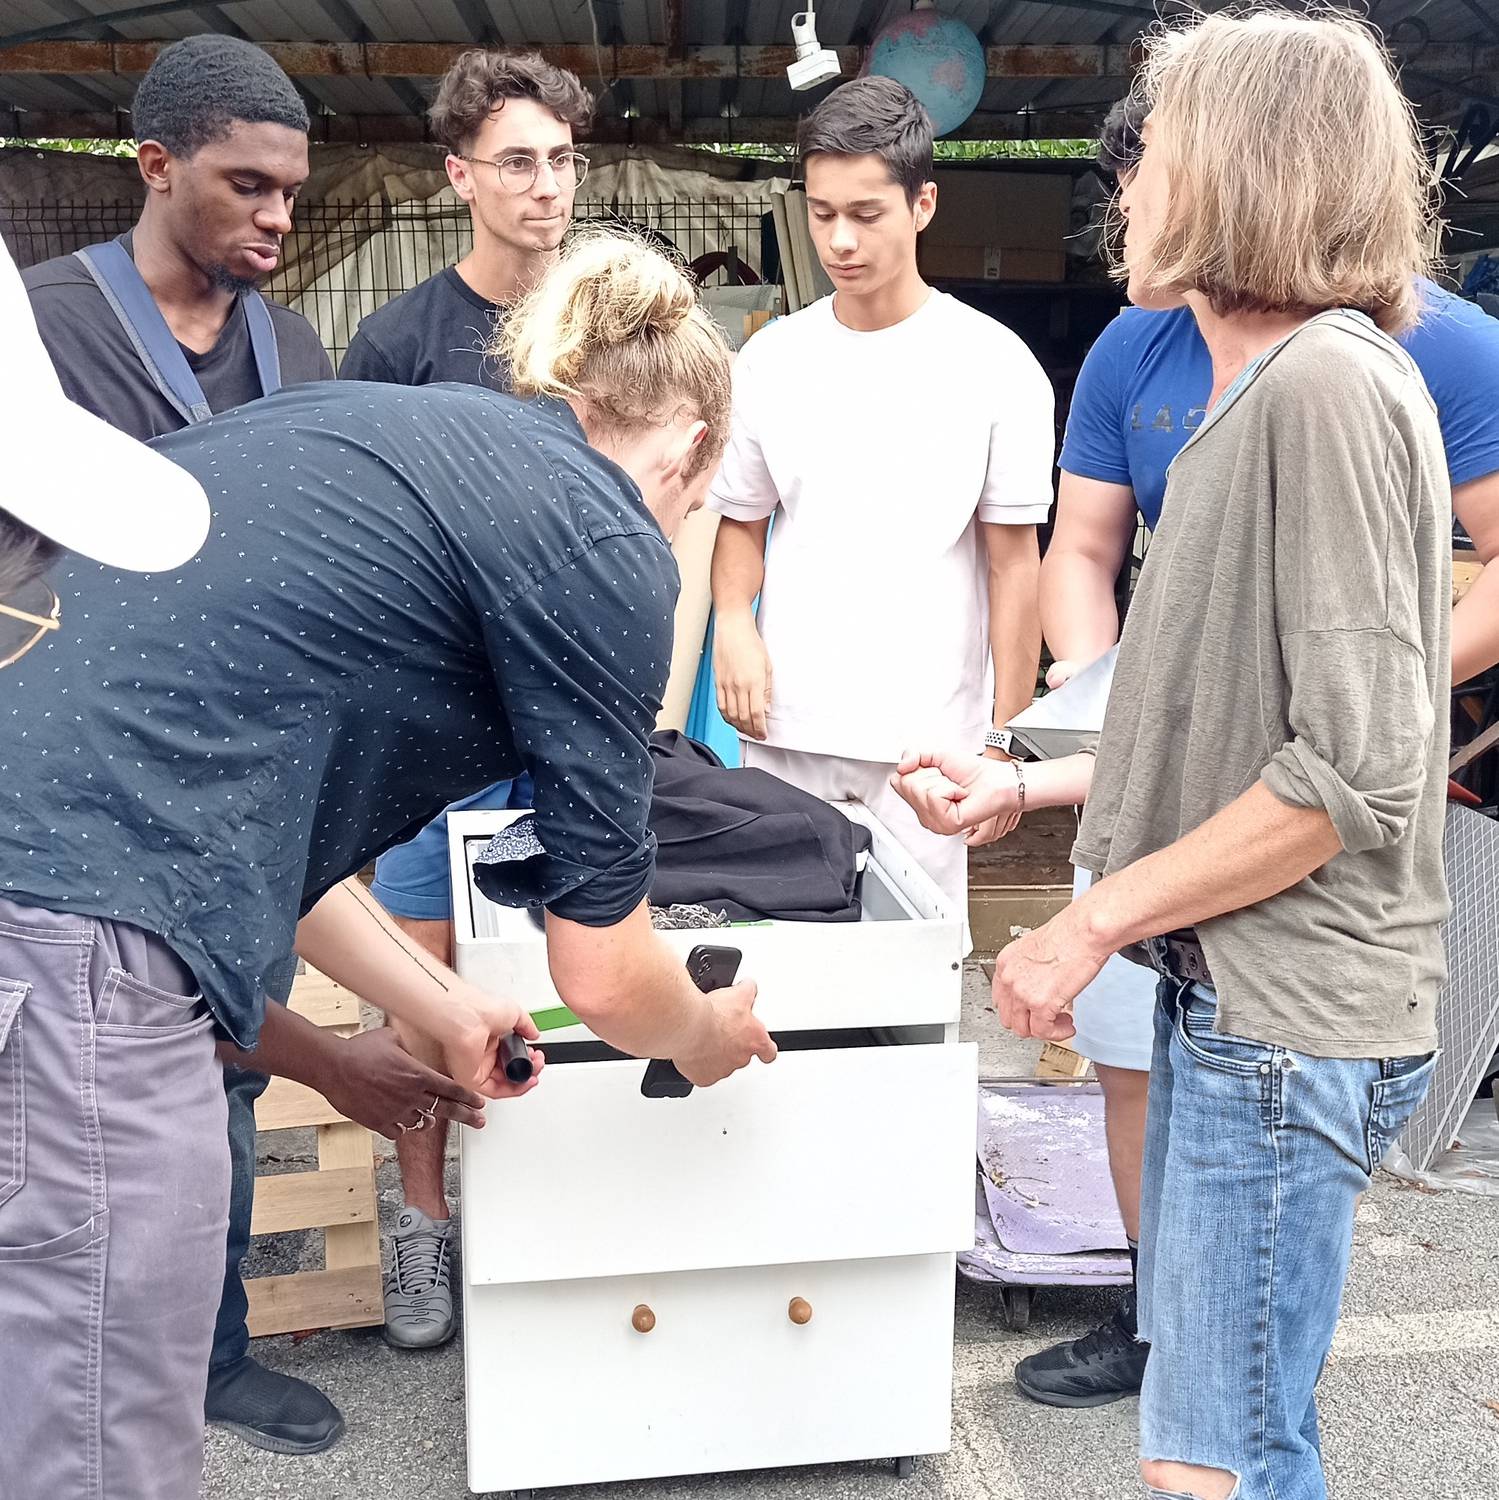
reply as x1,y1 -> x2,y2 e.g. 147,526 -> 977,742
464,1254 -> 953,1493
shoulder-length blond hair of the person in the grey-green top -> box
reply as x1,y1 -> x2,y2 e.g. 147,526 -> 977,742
1136,9 -> 1437,333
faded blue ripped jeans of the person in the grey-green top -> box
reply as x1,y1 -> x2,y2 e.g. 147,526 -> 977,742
1139,980 -> 1436,1500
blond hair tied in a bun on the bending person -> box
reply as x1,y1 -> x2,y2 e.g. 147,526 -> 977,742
495,225 -> 731,477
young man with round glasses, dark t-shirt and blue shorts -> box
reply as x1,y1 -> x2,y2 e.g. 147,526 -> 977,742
339,48 -> 593,1349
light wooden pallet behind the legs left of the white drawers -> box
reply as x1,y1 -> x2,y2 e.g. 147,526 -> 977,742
245,969 -> 384,1338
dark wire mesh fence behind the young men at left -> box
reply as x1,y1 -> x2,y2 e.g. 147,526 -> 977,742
0,198 -> 779,366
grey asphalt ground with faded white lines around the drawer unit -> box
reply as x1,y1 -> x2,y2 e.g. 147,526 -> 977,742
204,968 -> 1499,1500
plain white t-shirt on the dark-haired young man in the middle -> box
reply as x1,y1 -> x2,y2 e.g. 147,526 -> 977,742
708,291 -> 1055,761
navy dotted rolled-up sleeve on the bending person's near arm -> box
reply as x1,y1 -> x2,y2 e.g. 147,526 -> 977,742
485,534 -> 677,927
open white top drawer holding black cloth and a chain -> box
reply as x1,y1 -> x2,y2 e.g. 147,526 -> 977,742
447,803 -> 963,1043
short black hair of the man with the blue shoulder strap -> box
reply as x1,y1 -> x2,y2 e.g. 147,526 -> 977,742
131,36 -> 311,156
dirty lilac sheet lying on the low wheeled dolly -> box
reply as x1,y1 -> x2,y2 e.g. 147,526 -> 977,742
978,1080 -> 1127,1259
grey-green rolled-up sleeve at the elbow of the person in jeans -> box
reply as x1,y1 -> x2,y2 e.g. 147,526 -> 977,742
1260,630 -> 1434,854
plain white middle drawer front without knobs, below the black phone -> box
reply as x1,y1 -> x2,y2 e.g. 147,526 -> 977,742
462,1044 -> 978,1286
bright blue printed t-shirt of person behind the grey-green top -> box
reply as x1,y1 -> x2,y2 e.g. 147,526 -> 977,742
1061,281 -> 1499,527
